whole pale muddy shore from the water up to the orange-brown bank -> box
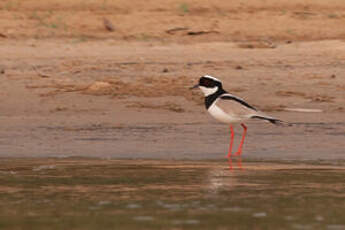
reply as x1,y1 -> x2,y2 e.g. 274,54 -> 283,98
0,41 -> 345,160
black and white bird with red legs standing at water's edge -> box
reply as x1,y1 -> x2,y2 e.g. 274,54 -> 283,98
190,75 -> 287,158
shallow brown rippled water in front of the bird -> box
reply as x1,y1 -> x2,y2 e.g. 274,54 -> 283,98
0,158 -> 345,229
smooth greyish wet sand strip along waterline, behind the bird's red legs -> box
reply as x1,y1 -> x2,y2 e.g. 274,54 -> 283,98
1,112 -> 345,160
